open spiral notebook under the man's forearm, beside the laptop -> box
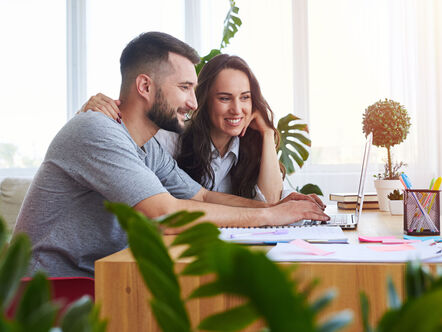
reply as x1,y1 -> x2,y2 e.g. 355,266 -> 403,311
220,225 -> 348,244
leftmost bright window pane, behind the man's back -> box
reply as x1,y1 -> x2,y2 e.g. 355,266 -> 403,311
0,0 -> 67,174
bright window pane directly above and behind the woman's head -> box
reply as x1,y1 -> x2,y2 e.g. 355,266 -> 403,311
198,0 -> 294,121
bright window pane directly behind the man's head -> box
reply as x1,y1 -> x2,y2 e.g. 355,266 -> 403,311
86,0 -> 185,99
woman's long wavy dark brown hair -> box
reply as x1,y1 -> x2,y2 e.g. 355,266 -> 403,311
177,54 -> 284,198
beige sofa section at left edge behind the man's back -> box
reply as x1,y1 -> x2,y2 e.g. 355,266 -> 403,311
0,178 -> 32,231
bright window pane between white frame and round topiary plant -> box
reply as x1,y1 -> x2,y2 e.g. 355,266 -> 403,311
308,0 -> 391,167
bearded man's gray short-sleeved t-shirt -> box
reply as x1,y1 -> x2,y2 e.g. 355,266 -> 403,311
14,111 -> 201,277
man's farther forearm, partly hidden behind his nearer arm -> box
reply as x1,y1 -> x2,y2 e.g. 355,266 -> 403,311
192,188 -> 270,208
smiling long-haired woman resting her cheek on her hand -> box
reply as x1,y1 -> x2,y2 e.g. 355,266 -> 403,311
82,54 -> 302,204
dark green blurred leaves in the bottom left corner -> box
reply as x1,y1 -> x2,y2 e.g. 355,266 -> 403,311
0,217 -> 107,332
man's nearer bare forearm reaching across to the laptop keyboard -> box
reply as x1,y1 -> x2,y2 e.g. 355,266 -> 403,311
134,189 -> 329,232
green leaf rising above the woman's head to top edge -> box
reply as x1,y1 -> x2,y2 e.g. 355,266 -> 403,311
195,0 -> 242,74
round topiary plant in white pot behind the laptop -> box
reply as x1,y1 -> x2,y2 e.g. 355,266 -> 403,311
362,99 -> 411,211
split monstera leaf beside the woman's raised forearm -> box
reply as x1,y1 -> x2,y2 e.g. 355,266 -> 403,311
278,114 -> 311,174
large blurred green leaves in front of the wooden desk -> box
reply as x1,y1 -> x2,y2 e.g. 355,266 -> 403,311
106,203 -> 351,332
